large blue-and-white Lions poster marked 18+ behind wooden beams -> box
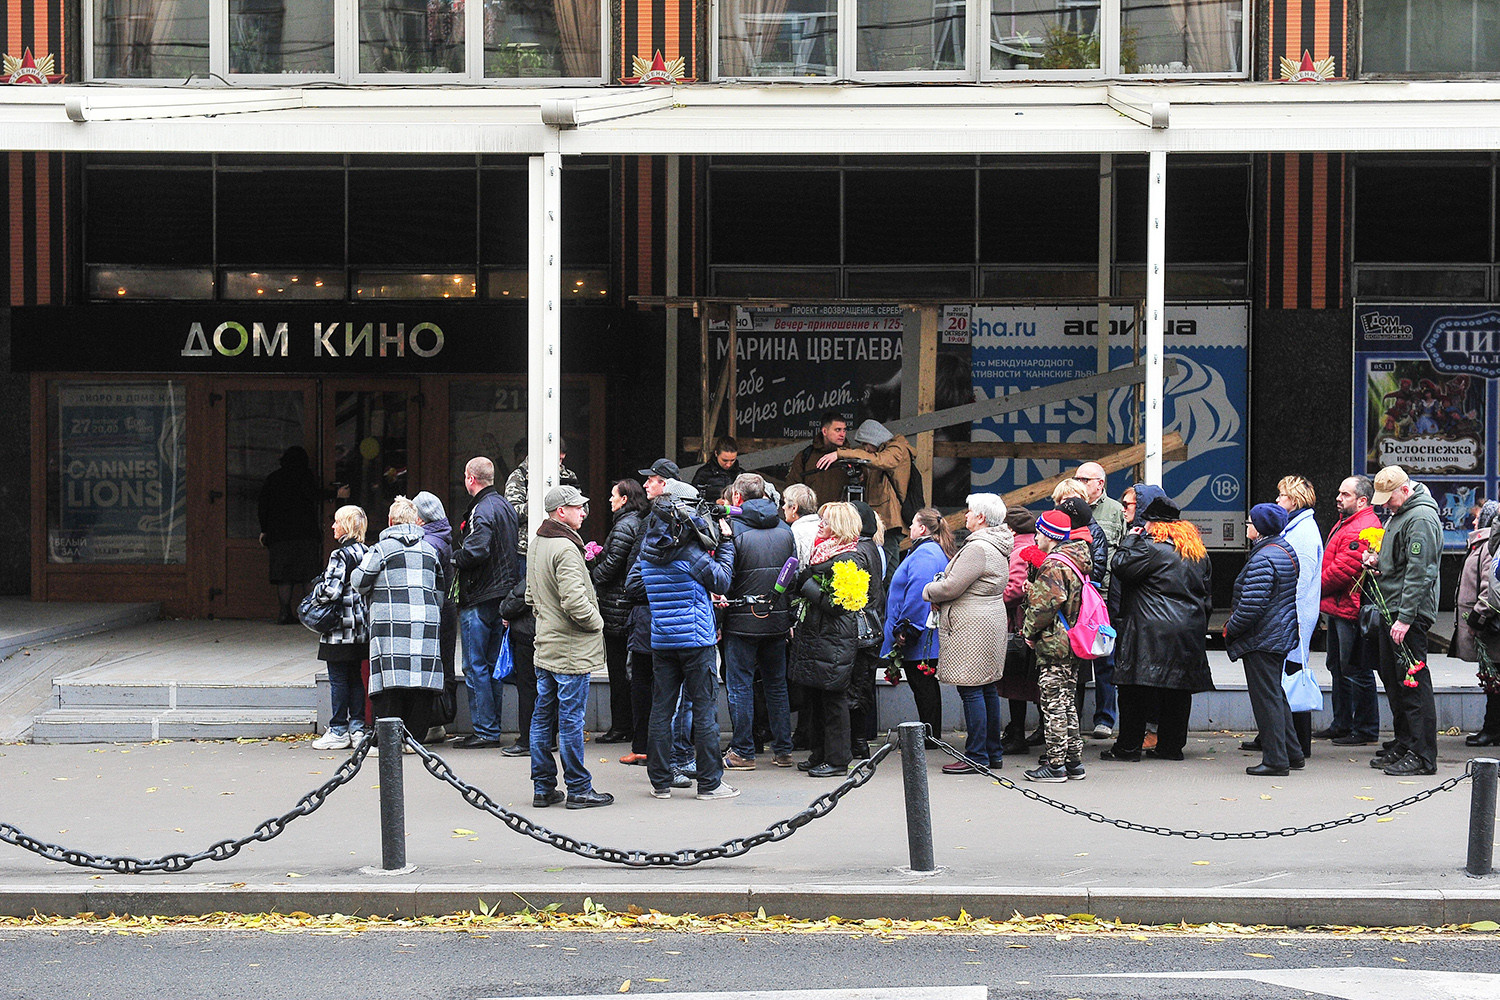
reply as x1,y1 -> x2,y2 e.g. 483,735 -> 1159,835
966,304 -> 1248,549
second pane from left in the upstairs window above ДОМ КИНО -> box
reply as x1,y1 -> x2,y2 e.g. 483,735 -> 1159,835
230,0 -> 333,73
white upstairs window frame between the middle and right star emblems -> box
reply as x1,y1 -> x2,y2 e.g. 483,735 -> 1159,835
708,0 -> 1256,85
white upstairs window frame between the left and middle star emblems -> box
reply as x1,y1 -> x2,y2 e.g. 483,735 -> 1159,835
83,0 -> 611,87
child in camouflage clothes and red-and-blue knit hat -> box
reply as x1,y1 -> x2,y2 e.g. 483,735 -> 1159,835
1022,510 -> 1092,781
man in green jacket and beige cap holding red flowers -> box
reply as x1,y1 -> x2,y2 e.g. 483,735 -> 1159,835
1365,465 -> 1443,778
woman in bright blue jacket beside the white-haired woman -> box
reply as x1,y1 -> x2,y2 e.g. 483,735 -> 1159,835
881,507 -> 959,736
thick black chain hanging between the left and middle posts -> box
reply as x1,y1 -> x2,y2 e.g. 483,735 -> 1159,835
407,735 -> 896,868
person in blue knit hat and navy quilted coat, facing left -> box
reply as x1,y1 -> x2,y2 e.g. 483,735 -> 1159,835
1224,504 -> 1305,778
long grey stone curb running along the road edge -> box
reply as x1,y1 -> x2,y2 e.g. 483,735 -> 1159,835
0,880 -> 1500,928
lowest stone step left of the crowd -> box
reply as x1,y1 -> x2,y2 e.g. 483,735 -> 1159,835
32,708 -> 318,744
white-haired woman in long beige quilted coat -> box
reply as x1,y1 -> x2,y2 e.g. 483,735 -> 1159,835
923,493 -> 1014,774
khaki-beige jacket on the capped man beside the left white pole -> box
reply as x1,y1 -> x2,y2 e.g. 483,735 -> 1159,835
527,517 -> 605,673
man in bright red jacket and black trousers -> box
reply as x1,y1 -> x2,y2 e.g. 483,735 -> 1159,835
1314,475 -> 1380,747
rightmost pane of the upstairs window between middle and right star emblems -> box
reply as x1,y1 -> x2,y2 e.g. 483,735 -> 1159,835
1121,0 -> 1245,75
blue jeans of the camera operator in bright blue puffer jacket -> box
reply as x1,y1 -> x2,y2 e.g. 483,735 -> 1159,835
647,646 -> 725,792
